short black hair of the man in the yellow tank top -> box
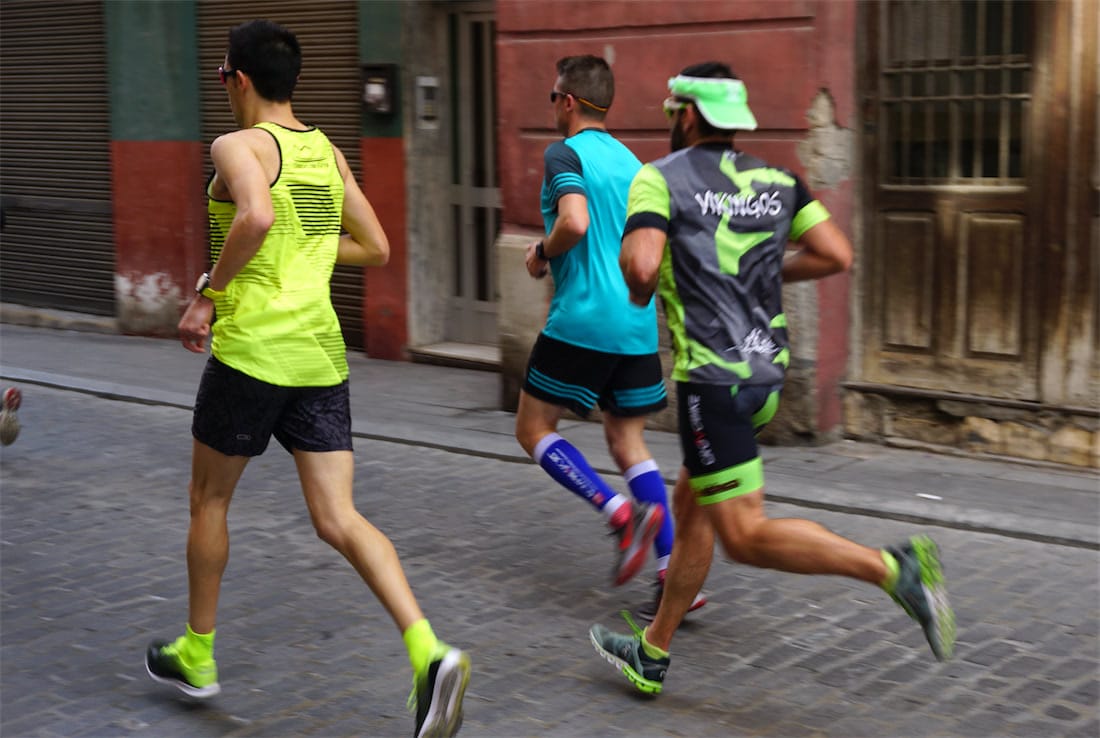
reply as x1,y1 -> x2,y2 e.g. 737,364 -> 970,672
227,20 -> 301,102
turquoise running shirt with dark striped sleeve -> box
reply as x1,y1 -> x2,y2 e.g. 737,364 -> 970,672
540,129 -> 657,355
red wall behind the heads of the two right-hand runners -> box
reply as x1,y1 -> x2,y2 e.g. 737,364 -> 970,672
497,0 -> 818,228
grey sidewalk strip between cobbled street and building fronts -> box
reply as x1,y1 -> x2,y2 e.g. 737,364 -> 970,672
0,324 -> 1100,549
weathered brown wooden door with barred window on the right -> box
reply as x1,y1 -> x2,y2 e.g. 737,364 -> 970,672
862,0 -> 1046,400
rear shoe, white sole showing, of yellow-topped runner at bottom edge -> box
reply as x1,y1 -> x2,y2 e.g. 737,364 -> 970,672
409,645 -> 470,738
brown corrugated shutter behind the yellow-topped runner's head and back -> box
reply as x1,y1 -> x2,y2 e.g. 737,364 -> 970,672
198,0 -> 364,349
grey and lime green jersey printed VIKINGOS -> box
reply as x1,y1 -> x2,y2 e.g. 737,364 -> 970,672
625,144 -> 829,385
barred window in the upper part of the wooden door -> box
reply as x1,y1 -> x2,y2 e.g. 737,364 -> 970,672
879,0 -> 1035,185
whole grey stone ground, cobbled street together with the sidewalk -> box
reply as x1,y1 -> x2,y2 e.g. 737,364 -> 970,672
0,326 -> 1100,738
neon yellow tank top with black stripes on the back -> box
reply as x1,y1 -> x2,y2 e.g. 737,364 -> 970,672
207,122 -> 348,387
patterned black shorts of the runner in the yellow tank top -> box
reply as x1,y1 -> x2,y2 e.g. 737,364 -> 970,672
191,356 -> 351,456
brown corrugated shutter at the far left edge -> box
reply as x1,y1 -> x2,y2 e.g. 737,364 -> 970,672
0,0 -> 114,316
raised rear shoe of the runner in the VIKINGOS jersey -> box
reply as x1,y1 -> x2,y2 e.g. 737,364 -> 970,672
887,536 -> 955,661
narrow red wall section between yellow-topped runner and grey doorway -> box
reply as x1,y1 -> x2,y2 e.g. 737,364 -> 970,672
360,137 -> 408,360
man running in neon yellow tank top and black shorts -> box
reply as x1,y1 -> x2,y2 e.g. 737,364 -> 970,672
145,21 -> 470,737
